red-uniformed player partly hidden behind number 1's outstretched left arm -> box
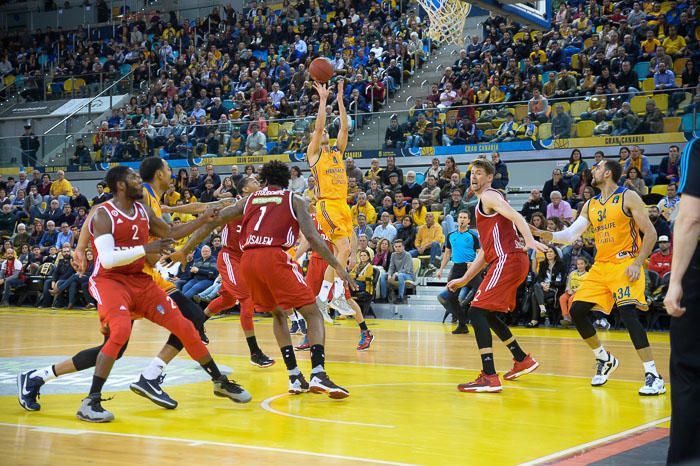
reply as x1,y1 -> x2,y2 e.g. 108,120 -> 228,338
204,177 -> 275,367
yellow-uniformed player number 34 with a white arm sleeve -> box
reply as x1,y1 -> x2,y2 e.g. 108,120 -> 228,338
531,160 -> 666,396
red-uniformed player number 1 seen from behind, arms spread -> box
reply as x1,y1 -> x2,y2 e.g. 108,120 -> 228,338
170,161 -> 353,398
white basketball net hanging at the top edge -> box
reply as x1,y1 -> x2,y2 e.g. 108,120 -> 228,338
418,0 -> 472,45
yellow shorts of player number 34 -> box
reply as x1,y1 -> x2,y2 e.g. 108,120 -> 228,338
574,257 -> 649,314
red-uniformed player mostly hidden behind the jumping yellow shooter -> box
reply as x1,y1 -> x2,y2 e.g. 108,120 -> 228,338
296,214 -> 374,351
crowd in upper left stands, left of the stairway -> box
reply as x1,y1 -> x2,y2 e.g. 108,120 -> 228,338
5,0 -> 427,165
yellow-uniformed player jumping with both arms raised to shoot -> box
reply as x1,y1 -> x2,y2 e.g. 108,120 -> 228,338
306,79 -> 355,315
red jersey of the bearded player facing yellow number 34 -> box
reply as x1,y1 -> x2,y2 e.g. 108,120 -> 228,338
476,189 -> 525,264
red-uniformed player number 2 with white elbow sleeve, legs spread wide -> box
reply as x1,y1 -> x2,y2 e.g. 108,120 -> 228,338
34,166 -> 252,422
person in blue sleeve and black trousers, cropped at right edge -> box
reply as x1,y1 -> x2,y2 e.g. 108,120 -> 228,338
664,138 -> 700,464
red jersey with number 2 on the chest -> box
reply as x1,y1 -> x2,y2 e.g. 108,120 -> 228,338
89,200 -> 150,277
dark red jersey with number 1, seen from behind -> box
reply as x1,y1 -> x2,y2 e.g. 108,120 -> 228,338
240,188 -> 299,251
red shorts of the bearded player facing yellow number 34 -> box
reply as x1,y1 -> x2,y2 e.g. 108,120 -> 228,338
472,253 -> 530,312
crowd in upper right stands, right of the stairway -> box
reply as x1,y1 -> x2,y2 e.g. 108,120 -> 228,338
385,6 -> 700,148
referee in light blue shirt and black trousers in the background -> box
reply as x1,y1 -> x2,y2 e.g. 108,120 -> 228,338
437,210 -> 481,334
